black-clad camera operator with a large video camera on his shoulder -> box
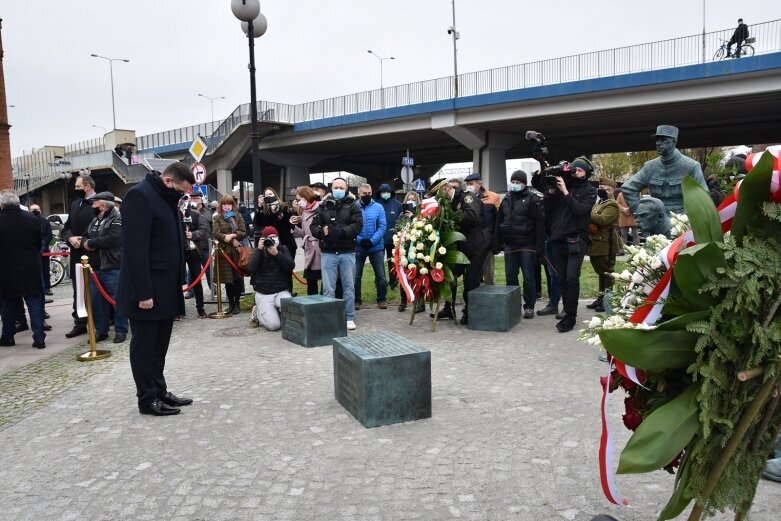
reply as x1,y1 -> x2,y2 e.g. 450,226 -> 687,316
543,157 -> 597,333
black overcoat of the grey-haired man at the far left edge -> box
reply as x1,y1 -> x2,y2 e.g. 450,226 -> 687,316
0,207 -> 43,298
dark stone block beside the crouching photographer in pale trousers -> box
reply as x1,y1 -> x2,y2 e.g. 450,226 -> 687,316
281,295 -> 347,347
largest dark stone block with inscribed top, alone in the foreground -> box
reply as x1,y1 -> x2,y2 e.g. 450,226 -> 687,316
333,332 -> 431,427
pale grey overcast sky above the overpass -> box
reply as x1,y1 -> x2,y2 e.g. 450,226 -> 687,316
0,0 -> 781,156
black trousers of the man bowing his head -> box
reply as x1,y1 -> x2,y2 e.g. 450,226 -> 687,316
130,319 -> 174,407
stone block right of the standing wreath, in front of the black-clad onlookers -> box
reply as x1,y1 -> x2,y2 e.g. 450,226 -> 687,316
469,286 -> 521,331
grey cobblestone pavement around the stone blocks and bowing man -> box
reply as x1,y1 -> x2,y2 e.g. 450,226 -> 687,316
0,294 -> 781,521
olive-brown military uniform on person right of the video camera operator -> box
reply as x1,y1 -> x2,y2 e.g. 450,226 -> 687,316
588,193 -> 621,308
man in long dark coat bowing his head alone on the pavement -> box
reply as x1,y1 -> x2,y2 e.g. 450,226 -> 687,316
117,162 -> 195,416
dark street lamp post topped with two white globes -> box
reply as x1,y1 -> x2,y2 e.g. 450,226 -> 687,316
231,0 -> 268,203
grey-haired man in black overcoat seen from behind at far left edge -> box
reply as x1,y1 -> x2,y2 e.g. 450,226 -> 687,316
0,190 -> 46,349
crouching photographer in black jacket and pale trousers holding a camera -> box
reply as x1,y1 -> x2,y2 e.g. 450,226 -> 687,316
247,226 -> 295,331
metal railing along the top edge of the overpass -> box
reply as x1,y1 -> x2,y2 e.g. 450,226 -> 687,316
131,20 -> 781,149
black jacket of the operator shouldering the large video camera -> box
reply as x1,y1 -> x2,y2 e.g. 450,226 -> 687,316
543,178 -> 597,241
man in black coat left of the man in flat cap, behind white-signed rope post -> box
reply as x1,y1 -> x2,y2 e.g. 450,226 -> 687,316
60,175 -> 100,338
